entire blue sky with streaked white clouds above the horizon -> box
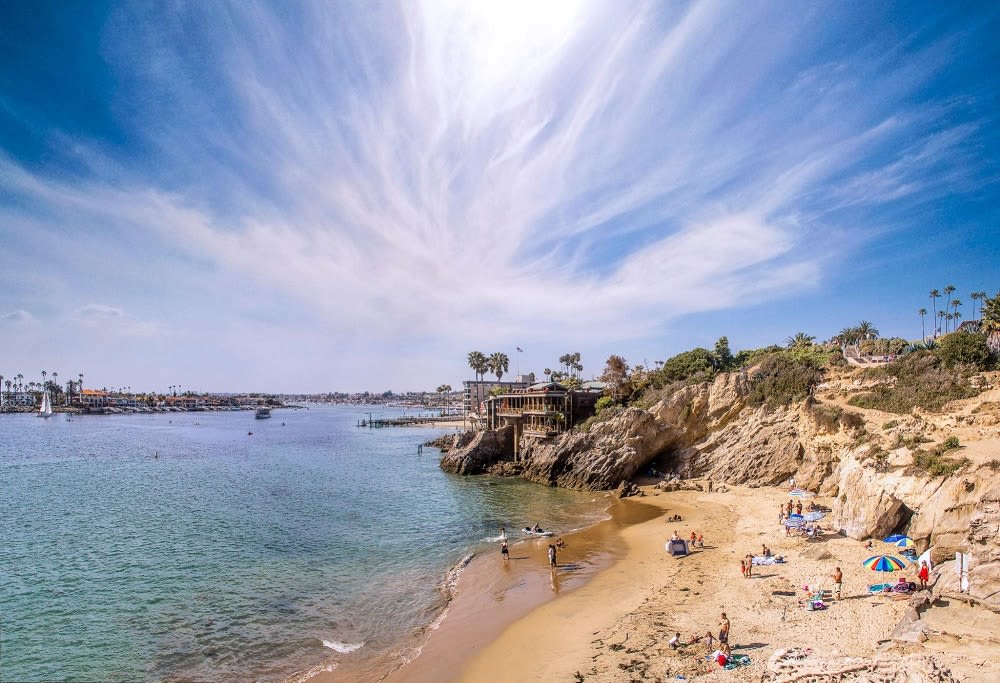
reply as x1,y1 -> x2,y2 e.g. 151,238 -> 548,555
0,0 -> 1000,391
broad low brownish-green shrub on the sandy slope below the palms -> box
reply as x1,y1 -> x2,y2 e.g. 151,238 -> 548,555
848,351 -> 978,414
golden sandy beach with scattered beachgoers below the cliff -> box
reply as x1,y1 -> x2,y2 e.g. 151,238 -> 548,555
313,480 -> 1000,682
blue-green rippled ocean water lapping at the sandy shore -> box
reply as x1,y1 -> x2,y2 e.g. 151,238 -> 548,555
0,406 -> 602,681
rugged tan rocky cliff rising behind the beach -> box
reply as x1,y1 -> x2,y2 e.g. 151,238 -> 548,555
442,373 -> 1000,607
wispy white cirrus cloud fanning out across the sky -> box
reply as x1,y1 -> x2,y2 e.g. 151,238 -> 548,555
0,2 -> 996,388
